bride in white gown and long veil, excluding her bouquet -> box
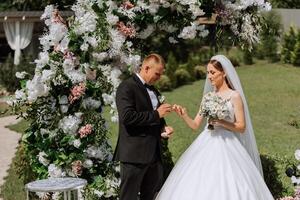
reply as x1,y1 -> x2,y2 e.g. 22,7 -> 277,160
156,55 -> 274,200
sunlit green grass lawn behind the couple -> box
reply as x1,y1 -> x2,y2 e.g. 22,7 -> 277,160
0,61 -> 300,200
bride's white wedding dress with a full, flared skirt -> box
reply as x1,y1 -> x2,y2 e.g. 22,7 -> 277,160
156,98 -> 274,200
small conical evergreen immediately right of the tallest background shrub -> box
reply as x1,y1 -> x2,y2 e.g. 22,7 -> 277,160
281,26 -> 297,63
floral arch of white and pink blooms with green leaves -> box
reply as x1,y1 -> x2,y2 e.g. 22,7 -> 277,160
11,0 -> 270,199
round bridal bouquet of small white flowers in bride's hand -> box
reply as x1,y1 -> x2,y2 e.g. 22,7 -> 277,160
199,92 -> 230,130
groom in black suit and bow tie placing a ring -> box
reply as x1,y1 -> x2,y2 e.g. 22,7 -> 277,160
114,54 -> 173,200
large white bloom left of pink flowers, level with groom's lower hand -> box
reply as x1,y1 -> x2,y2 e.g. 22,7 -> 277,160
58,115 -> 81,135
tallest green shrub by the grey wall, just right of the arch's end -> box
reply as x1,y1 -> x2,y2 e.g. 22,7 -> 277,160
254,11 -> 282,62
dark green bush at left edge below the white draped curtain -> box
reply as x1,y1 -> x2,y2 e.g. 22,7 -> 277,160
0,55 -> 35,92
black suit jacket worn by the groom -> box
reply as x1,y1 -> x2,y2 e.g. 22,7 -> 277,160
114,75 -> 165,164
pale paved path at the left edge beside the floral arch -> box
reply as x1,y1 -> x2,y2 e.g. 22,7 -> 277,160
0,116 -> 21,200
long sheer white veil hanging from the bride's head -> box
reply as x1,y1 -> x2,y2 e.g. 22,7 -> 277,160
203,55 -> 263,176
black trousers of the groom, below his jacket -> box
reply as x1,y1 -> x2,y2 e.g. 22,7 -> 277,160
120,161 -> 163,200
